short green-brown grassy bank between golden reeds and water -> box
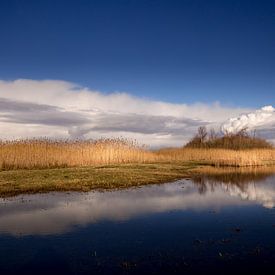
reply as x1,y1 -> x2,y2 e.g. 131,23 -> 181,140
0,163 -> 197,197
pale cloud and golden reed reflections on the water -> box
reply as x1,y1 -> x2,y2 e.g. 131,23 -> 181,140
0,168 -> 275,235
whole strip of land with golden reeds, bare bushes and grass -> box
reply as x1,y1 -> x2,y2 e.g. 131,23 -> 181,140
0,127 -> 275,196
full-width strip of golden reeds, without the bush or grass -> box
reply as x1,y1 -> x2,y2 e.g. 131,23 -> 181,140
0,139 -> 275,170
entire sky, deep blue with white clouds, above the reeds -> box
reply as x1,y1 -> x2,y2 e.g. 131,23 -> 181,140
0,0 -> 275,146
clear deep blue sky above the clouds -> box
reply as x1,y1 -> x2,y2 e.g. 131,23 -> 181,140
0,0 -> 275,108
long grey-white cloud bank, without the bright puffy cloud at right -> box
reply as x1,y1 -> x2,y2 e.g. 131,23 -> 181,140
0,79 -> 274,146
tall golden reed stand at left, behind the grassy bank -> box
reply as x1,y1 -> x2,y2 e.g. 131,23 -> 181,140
0,139 -> 154,170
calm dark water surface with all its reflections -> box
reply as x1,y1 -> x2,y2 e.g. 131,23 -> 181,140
0,171 -> 275,274
